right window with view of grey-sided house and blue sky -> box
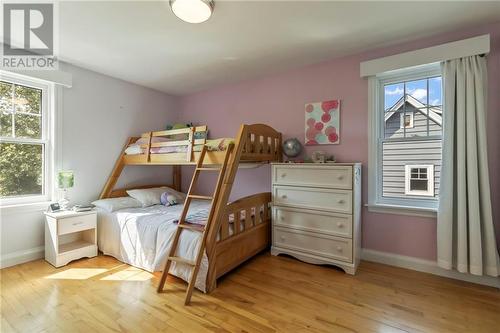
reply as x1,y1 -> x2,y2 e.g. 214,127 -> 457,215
369,64 -> 443,211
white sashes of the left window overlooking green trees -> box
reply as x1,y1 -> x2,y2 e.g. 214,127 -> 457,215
0,71 -> 54,206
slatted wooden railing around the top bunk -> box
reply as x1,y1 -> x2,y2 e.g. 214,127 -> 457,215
123,124 -> 282,165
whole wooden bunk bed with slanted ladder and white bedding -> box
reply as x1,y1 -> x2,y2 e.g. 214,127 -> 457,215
98,124 -> 282,294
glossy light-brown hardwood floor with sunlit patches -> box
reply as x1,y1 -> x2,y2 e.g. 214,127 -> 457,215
0,253 -> 500,333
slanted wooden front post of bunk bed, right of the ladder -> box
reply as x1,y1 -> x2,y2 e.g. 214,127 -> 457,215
206,125 -> 247,292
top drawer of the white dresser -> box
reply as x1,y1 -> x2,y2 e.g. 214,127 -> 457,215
273,164 -> 352,190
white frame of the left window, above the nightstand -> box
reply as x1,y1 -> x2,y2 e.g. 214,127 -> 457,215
0,71 -> 56,207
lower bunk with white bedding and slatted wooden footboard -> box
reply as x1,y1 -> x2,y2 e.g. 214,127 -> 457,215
97,190 -> 271,292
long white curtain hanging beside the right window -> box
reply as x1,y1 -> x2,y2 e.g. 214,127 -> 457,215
437,55 -> 500,276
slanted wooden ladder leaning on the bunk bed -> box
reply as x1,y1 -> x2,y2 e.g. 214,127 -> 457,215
157,144 -> 234,305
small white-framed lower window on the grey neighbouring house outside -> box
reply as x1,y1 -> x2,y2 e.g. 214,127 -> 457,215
405,165 -> 434,196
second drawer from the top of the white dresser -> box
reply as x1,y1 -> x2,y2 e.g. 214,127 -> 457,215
273,185 -> 352,214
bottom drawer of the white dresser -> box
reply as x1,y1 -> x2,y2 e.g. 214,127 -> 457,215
273,227 -> 352,262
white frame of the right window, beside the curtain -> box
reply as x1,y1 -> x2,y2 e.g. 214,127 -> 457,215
368,63 -> 442,217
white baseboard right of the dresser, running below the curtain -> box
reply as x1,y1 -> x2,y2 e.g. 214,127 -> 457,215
361,249 -> 500,289
